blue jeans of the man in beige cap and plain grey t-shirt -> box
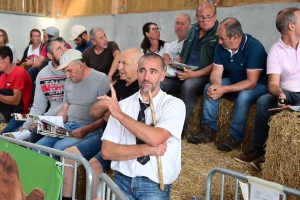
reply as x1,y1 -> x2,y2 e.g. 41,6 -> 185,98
33,121 -> 102,159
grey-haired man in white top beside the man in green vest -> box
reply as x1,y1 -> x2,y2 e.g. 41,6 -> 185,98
162,13 -> 191,65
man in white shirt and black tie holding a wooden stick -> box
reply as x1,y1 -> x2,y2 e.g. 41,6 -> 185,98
99,53 -> 185,199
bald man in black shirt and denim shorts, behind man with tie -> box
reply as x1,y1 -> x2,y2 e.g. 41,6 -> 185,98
63,48 -> 143,200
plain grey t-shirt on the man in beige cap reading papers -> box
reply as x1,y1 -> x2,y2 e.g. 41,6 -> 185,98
63,69 -> 110,123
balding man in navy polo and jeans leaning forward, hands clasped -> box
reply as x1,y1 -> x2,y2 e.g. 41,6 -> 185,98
188,18 -> 268,152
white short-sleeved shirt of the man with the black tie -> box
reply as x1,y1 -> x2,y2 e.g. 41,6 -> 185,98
102,90 -> 185,184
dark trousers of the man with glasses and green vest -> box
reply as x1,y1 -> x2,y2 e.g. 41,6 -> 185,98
160,76 -> 209,131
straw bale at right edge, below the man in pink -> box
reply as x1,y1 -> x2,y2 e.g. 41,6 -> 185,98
262,111 -> 300,199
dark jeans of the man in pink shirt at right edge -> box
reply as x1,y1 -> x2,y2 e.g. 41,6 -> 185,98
252,90 -> 300,154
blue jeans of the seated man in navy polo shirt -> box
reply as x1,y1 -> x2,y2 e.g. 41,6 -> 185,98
202,78 -> 268,142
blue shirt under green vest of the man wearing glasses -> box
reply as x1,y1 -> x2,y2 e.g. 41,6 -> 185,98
180,25 -> 205,66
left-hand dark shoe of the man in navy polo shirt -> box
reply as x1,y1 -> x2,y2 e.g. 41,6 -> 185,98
187,124 -> 217,144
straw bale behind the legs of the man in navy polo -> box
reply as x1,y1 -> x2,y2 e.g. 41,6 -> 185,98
188,97 -> 256,152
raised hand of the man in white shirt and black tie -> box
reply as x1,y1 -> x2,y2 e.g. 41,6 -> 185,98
97,84 -> 122,118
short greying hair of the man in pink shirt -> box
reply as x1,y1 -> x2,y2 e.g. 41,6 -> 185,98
276,7 -> 299,33
